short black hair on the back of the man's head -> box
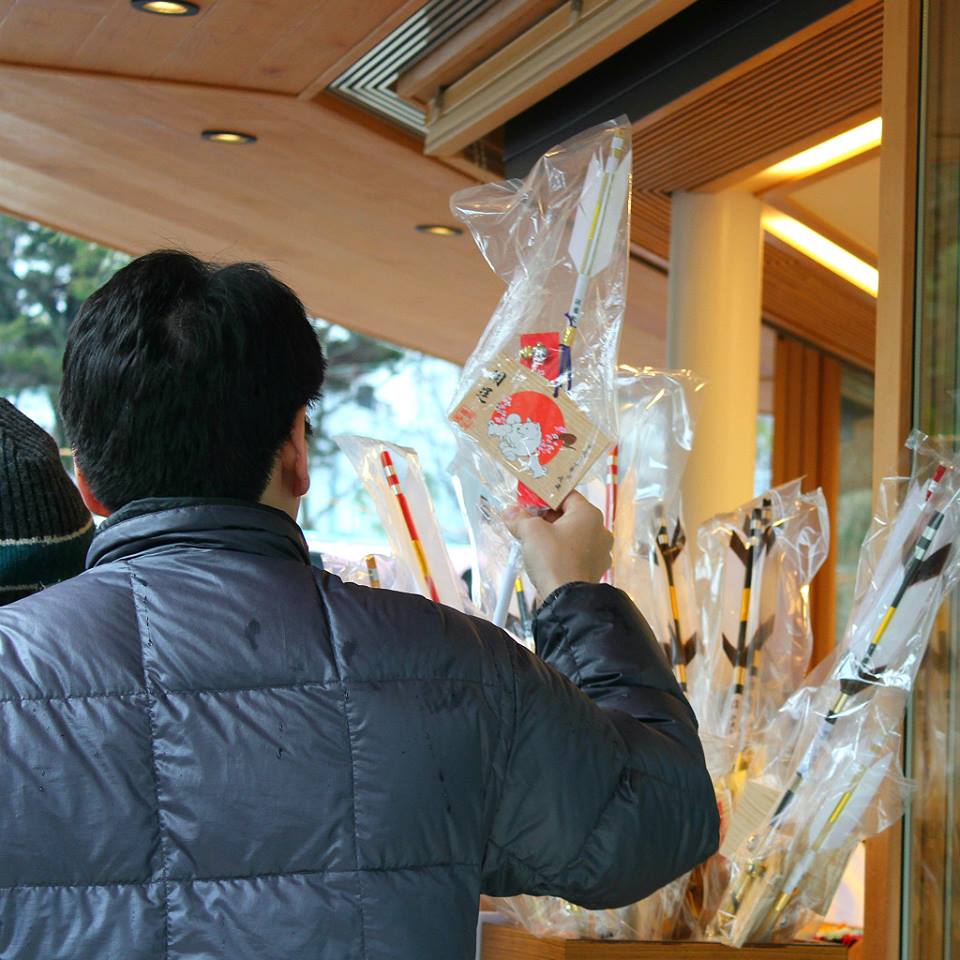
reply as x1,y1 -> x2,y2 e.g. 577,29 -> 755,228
60,250 -> 324,510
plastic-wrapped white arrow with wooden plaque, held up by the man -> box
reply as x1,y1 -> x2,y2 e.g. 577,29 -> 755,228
449,118 -> 631,625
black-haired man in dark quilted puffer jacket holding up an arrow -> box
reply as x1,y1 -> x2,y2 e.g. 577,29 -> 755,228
0,252 -> 717,960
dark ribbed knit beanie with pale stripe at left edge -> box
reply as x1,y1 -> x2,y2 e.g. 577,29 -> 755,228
0,397 -> 93,606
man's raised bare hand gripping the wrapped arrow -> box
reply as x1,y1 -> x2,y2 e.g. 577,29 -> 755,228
504,491 -> 613,598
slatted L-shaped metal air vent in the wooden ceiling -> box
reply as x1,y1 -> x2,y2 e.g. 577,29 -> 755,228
328,0 -> 494,136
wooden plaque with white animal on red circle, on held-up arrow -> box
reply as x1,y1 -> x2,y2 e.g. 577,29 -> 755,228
450,357 -> 611,509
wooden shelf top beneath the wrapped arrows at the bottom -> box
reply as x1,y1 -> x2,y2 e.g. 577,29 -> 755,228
480,923 -> 847,960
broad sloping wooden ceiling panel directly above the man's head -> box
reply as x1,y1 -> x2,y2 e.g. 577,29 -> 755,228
0,67 -> 666,363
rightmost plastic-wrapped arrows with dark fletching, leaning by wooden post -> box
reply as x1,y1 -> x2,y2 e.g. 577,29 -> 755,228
711,435 -> 960,945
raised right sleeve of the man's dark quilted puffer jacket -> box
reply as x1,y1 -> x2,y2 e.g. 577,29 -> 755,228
484,583 -> 719,907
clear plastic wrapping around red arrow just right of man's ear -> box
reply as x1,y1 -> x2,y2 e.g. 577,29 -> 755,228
334,436 -> 464,611
